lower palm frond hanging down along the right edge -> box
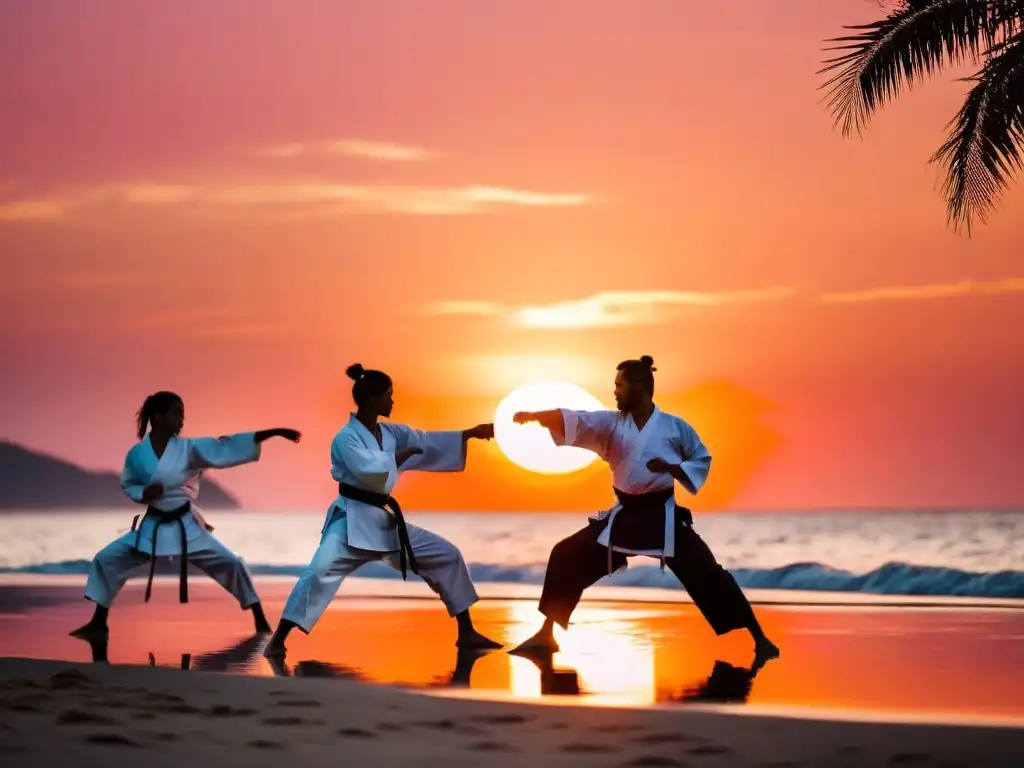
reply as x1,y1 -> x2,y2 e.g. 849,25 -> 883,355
932,27 -> 1024,233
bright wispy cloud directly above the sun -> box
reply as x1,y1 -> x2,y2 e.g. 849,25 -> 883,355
431,286 -> 797,329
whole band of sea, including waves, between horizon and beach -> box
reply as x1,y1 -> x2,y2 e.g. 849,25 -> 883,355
0,510 -> 1024,598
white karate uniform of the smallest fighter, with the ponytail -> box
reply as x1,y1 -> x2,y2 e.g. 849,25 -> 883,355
85,432 -> 261,608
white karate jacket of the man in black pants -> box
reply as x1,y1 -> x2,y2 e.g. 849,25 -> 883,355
555,406 -> 711,565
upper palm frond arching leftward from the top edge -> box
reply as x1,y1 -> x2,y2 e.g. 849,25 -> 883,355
818,0 -> 995,135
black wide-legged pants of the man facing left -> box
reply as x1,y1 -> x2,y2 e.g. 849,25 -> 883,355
539,511 -> 754,635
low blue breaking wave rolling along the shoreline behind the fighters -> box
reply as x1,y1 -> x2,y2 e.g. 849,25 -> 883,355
0,560 -> 1024,598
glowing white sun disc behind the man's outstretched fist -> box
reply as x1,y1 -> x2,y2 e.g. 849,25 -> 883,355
495,381 -> 604,474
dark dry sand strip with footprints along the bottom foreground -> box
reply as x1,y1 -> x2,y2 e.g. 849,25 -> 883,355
0,659 -> 1024,767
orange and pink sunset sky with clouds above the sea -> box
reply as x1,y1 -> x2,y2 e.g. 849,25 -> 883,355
0,0 -> 1024,518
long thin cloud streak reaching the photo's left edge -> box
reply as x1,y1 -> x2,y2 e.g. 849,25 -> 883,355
0,181 -> 597,221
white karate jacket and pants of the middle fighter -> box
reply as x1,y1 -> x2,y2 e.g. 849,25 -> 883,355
282,414 -> 479,633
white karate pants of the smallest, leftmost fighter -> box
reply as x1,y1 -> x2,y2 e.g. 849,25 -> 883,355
85,531 -> 259,610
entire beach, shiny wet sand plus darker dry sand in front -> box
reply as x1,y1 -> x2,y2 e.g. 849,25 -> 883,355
0,577 -> 1024,766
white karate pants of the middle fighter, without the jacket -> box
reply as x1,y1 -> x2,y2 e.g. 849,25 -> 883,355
281,517 -> 479,634
